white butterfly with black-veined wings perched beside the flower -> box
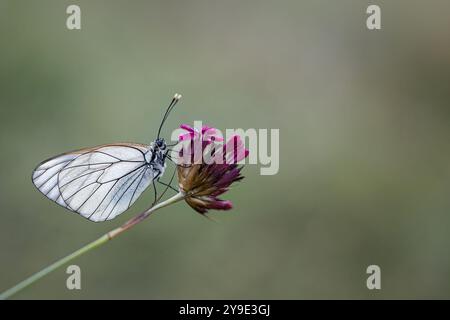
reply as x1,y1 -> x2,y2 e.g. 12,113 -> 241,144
32,94 -> 181,222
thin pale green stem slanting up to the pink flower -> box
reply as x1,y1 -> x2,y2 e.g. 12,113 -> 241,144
0,192 -> 185,300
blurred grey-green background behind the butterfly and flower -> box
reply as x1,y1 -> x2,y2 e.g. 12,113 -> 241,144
0,0 -> 450,299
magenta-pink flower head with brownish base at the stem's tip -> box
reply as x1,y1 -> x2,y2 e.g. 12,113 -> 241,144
177,125 -> 249,214
